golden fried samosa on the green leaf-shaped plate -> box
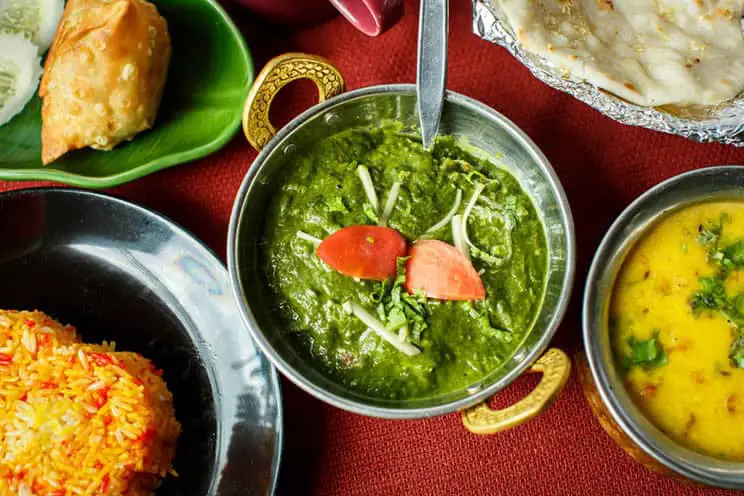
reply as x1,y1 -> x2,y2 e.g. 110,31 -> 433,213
39,0 -> 171,165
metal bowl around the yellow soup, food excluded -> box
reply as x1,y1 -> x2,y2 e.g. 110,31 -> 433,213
583,166 -> 744,489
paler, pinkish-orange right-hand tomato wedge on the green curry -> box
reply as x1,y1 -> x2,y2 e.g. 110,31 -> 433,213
404,240 -> 486,300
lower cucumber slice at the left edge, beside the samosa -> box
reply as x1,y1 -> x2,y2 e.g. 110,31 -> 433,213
0,34 -> 41,126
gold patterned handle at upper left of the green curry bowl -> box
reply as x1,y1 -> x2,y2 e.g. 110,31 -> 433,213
243,53 -> 344,150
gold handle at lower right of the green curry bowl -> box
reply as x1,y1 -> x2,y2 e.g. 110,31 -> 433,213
462,348 -> 571,434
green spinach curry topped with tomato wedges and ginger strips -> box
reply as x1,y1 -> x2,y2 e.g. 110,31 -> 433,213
259,125 -> 548,399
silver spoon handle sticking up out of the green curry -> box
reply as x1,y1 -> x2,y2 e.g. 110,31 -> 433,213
416,0 -> 449,150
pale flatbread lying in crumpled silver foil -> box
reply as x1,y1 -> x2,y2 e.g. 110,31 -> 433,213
493,0 -> 744,106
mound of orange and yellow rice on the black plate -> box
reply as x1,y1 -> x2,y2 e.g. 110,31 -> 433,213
0,311 -> 181,496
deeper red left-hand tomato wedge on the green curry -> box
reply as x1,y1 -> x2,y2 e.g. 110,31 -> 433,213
315,226 -> 408,280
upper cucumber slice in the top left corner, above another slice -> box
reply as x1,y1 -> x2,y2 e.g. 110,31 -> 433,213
0,0 -> 65,53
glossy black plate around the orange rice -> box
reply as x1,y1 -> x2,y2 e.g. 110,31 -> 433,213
0,188 -> 282,496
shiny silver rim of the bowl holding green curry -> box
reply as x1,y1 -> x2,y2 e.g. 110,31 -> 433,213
227,84 -> 576,419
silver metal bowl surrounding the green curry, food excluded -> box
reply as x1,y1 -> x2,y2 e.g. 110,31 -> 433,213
228,54 -> 574,423
